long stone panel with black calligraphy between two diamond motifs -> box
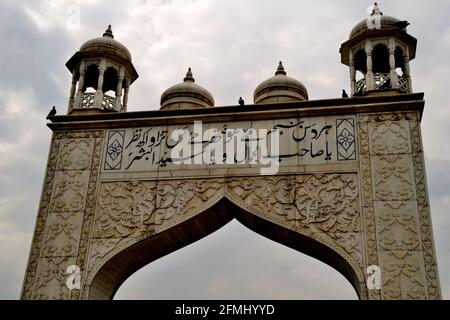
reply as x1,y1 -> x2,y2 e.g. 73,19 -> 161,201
102,116 -> 356,173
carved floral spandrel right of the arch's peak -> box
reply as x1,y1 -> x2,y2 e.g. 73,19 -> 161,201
227,174 -> 362,265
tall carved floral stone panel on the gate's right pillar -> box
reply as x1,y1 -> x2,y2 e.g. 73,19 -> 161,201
362,117 -> 436,299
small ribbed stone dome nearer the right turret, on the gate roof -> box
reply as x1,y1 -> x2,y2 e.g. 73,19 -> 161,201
253,61 -> 308,104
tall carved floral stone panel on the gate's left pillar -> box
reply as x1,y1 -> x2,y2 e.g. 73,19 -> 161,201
22,131 -> 102,299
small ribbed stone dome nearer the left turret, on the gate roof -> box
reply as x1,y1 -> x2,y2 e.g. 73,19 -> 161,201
161,68 -> 214,110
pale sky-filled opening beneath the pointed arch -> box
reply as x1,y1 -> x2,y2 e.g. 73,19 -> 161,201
114,219 -> 358,300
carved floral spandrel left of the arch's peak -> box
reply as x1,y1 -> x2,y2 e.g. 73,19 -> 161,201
94,179 -> 223,238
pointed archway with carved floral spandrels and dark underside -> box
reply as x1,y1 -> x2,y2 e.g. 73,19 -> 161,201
84,175 -> 367,299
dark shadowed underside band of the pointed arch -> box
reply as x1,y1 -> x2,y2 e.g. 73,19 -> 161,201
88,198 -> 365,299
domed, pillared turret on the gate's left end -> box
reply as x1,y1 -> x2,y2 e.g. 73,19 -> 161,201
66,26 -> 138,114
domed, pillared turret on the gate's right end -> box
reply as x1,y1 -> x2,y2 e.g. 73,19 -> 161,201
340,3 -> 417,96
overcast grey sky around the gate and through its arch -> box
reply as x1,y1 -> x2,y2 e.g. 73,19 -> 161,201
0,0 -> 450,299
